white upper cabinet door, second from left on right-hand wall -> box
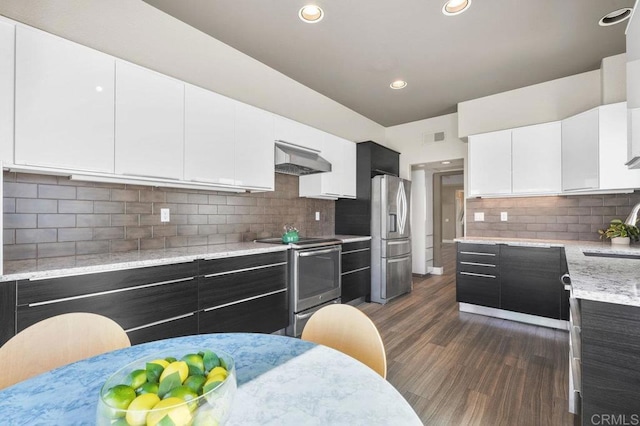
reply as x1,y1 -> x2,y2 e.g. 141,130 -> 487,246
511,121 -> 562,194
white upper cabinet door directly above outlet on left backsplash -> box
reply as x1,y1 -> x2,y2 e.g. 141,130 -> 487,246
115,61 -> 184,179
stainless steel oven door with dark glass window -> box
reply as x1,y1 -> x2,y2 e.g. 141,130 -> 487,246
291,245 -> 342,312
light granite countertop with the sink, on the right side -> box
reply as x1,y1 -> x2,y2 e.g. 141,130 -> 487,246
456,237 -> 640,306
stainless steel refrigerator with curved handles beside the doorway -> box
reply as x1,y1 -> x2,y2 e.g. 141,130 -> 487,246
371,175 -> 413,303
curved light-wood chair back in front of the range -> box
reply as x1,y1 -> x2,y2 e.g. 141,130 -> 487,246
302,304 -> 387,379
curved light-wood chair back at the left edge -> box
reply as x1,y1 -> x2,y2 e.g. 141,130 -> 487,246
0,312 -> 131,389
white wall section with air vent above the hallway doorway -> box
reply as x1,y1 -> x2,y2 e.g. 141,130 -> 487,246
386,114 -> 467,179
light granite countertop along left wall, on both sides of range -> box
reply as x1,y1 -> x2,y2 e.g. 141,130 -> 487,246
0,235 -> 371,281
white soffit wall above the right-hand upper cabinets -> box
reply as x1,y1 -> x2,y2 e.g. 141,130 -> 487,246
458,70 -> 602,138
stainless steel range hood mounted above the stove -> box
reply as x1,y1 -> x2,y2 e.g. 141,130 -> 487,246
275,140 -> 331,176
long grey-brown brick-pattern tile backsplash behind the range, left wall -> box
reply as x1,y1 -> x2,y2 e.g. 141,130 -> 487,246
3,172 -> 335,262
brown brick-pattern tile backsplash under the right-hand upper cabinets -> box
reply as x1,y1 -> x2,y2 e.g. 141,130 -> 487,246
466,192 -> 640,241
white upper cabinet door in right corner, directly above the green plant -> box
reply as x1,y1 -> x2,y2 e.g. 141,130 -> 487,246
598,102 -> 640,189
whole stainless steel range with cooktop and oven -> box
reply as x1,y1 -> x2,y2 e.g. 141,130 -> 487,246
256,238 -> 342,337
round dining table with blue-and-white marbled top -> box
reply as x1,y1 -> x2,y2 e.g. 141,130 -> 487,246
0,333 -> 422,426
